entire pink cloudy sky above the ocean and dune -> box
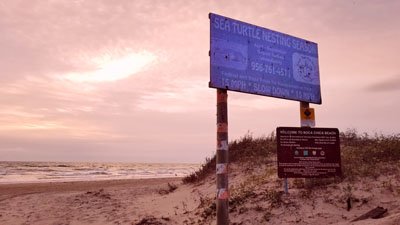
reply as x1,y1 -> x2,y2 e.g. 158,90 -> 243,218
0,0 -> 400,163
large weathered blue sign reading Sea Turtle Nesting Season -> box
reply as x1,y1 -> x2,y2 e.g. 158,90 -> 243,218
210,13 -> 322,104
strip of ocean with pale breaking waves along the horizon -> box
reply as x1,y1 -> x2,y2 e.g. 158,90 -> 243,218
0,162 -> 200,184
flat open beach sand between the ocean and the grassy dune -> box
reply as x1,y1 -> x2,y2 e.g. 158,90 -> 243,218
0,178 -> 186,225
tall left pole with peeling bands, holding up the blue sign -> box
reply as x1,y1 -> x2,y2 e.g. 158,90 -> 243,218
216,89 -> 229,225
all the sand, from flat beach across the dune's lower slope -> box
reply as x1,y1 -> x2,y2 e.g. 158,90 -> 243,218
0,170 -> 400,225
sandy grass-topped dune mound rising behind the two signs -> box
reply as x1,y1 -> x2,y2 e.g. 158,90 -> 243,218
183,130 -> 400,224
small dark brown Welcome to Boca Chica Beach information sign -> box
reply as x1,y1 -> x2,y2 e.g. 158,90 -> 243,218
276,127 -> 342,178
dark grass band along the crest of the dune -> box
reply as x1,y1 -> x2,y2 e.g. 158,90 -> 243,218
183,129 -> 400,186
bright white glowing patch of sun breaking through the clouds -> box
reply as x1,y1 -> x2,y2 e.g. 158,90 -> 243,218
65,51 -> 157,82
